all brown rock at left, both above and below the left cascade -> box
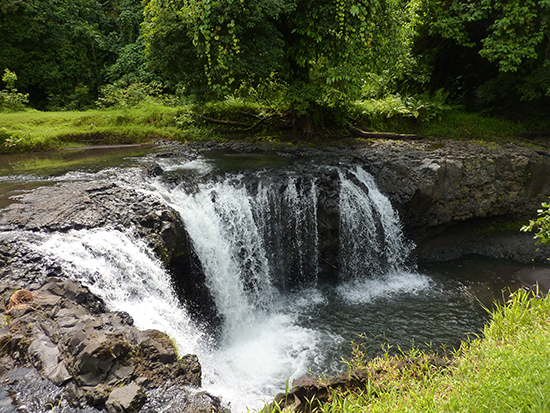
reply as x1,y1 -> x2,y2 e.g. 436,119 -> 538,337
0,182 -> 223,412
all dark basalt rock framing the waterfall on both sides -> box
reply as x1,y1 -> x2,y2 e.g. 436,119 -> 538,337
0,140 -> 550,413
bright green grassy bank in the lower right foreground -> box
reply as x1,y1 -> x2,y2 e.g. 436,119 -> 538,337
270,290 -> 550,413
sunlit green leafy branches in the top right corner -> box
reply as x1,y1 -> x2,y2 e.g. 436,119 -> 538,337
424,0 -> 550,100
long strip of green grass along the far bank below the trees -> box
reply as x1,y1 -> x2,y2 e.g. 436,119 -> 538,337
0,100 -> 544,153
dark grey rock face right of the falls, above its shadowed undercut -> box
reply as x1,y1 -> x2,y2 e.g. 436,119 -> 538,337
358,141 -> 550,232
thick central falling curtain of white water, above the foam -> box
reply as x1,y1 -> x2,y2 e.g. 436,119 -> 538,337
165,178 -> 275,334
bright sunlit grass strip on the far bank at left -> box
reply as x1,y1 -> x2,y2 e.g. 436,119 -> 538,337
0,105 -> 220,153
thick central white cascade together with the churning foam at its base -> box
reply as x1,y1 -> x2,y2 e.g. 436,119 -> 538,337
155,176 -> 326,411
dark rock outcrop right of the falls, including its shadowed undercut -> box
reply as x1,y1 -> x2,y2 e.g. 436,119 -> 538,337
353,140 -> 550,262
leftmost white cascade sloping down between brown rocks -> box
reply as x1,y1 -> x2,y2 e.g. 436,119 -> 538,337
29,229 -> 208,354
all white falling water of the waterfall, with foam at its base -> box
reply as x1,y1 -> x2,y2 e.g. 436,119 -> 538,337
23,162 -> 427,413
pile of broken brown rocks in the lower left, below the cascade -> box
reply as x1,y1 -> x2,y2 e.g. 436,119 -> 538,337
0,277 -> 205,412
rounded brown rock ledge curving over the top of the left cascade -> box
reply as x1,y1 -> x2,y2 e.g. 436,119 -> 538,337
0,182 -> 186,263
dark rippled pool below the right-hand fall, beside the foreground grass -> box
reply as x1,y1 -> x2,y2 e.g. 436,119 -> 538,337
289,257 -> 525,373
